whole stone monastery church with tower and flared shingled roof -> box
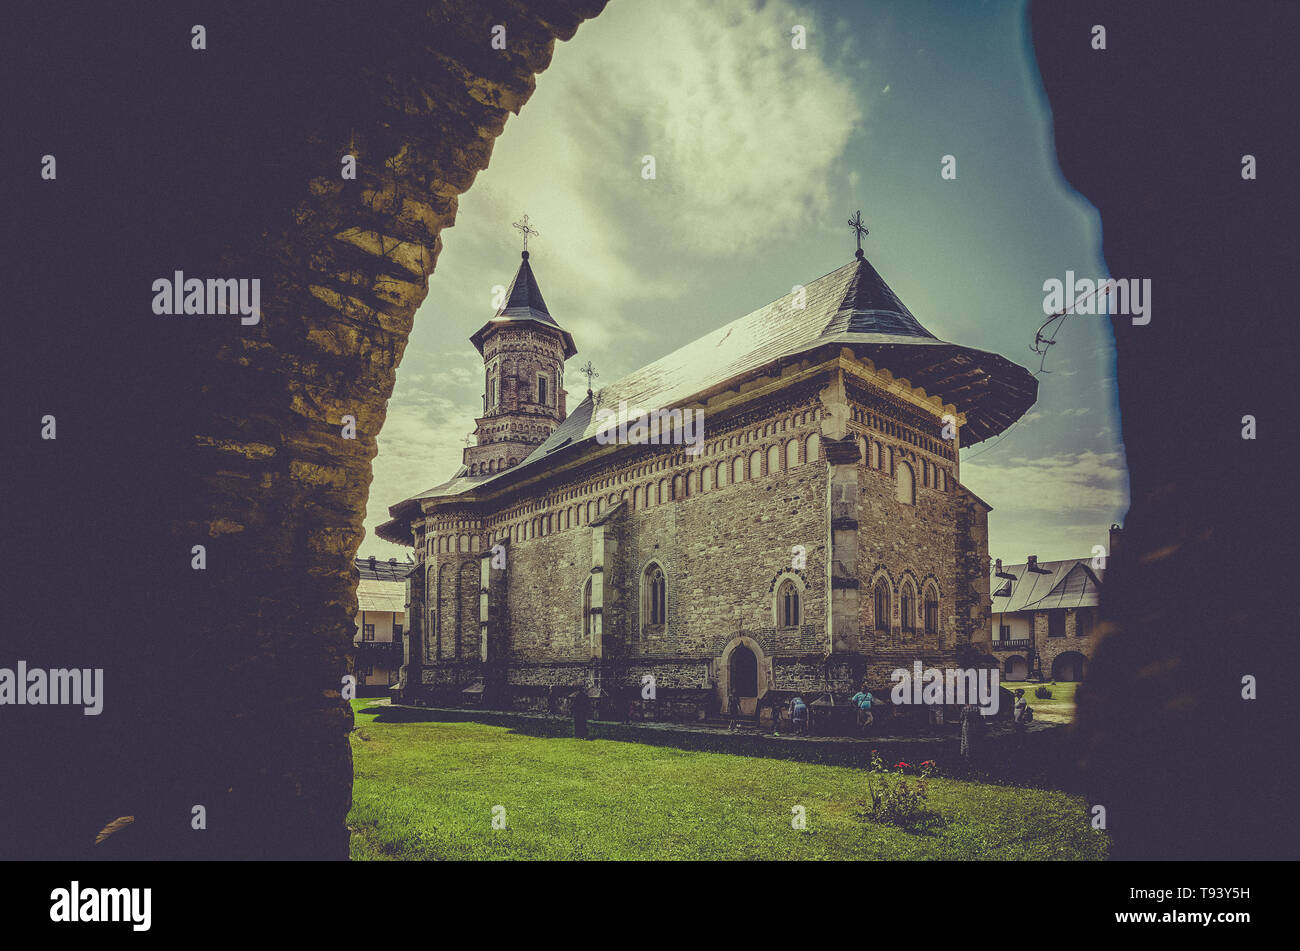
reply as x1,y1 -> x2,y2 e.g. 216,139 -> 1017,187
378,228 -> 1037,718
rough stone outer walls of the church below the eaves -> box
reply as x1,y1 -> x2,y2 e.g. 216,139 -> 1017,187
403,381 -> 989,718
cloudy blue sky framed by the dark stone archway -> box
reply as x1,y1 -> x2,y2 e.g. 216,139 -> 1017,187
360,0 -> 1128,564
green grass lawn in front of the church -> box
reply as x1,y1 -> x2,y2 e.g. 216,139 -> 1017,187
347,700 -> 1106,860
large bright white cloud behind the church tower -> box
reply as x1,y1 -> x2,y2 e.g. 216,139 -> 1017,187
367,0 -> 863,550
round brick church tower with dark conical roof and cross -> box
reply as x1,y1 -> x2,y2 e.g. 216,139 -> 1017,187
464,235 -> 577,476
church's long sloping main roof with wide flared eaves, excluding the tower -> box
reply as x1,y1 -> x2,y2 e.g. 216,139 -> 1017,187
378,252 -> 1039,544
